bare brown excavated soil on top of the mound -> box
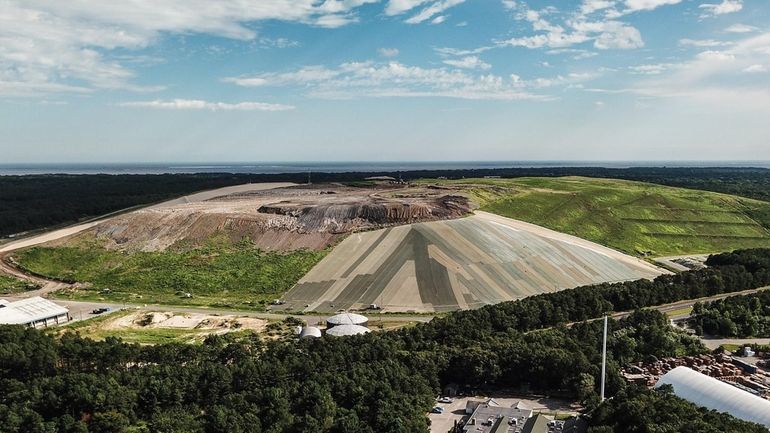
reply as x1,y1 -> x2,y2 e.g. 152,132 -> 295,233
72,184 -> 471,251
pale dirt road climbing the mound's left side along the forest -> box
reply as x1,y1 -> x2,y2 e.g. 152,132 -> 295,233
0,182 -> 296,298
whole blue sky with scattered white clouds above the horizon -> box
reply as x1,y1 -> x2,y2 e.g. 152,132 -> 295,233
0,0 -> 770,163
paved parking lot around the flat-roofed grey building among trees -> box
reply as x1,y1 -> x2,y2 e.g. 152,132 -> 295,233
428,395 -> 579,433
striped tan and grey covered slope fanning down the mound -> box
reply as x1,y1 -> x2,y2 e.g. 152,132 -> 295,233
282,212 -> 665,312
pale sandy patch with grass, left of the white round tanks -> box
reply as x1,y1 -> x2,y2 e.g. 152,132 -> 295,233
56,310 -> 268,344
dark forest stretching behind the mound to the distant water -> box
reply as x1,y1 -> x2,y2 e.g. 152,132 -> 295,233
0,167 -> 770,237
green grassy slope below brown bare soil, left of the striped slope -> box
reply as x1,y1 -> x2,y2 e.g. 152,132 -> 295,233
16,242 -> 326,310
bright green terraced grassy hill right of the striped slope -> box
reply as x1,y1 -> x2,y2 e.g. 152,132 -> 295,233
426,177 -> 770,256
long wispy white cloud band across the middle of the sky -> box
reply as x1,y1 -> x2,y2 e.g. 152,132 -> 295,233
225,60 -> 593,100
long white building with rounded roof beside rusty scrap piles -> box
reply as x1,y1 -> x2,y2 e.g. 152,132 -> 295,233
655,367 -> 770,428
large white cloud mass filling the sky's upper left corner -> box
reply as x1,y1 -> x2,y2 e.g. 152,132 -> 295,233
0,0 -> 378,96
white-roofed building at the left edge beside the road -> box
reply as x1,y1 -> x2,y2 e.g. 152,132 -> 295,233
0,296 -> 70,328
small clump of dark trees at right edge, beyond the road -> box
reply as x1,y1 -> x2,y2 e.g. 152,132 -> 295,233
690,291 -> 770,338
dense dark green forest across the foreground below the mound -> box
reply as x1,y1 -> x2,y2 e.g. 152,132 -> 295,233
0,250 -> 770,433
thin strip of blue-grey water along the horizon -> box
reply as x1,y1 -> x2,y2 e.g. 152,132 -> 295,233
0,161 -> 770,175
